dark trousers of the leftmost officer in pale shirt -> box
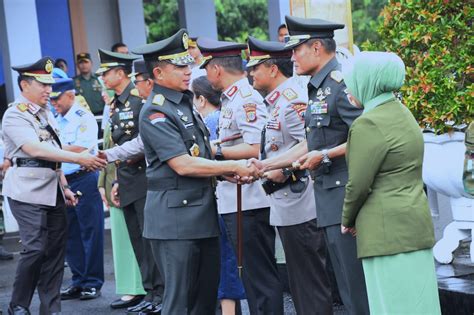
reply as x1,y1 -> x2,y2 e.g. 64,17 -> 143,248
8,196 -> 67,314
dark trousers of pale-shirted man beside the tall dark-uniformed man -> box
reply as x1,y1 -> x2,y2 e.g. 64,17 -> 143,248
278,219 -> 333,315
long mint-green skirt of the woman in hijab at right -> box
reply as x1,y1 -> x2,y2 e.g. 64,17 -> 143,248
362,249 -> 441,315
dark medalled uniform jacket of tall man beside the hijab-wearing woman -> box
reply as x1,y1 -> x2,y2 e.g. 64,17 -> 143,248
305,57 -> 362,226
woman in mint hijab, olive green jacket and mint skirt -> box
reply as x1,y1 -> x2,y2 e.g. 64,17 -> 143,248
341,52 -> 441,315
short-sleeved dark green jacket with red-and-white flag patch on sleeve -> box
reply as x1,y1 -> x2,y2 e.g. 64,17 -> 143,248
140,84 -> 219,239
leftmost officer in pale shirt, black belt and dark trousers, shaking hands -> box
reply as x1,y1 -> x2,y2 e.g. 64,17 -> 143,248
2,57 -> 106,314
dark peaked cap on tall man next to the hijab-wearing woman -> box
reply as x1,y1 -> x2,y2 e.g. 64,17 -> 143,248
285,15 -> 344,48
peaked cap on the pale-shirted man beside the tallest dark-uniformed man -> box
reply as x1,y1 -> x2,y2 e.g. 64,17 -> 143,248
247,36 -> 292,68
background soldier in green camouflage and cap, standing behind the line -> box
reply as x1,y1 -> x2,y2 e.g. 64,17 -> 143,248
74,53 -> 105,115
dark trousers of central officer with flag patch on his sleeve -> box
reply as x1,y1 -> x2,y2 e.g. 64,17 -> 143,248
151,237 -> 220,315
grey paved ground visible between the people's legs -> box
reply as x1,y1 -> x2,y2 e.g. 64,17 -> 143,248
0,232 -> 346,315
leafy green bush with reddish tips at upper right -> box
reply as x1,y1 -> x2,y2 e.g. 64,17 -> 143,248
363,0 -> 474,133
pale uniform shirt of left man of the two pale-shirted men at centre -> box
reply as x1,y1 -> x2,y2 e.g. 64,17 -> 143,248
217,78 -> 270,214
